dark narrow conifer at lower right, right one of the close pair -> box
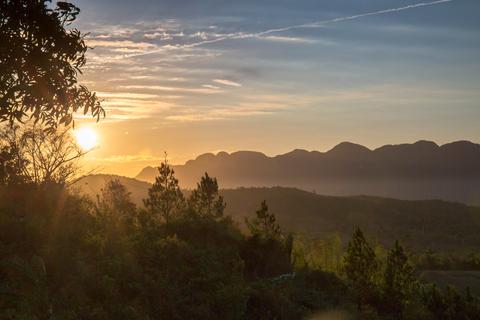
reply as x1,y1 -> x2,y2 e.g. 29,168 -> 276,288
383,241 -> 417,319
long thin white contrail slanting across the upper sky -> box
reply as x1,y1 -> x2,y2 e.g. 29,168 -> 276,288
127,0 -> 454,58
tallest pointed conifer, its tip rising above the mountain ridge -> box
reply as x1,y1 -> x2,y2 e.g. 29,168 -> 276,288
143,159 -> 185,224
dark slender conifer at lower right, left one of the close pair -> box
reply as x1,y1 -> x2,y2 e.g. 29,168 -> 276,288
344,228 -> 378,310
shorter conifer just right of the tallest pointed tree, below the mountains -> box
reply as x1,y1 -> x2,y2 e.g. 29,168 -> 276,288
188,173 -> 225,219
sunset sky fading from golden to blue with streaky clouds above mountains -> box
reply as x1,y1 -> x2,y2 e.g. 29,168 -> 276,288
74,0 -> 480,176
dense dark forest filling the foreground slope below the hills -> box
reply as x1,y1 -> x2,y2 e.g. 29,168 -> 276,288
0,158 -> 480,319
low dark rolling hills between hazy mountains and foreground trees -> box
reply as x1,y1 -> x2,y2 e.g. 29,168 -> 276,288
76,175 -> 480,250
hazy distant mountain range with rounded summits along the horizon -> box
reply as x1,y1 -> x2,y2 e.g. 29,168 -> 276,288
136,141 -> 480,205
